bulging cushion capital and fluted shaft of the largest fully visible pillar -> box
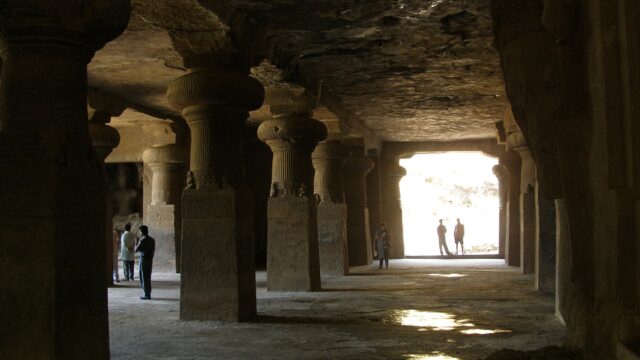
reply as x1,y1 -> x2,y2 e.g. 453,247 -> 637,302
167,68 -> 264,188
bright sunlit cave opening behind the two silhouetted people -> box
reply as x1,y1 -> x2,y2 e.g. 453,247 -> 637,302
400,151 -> 499,257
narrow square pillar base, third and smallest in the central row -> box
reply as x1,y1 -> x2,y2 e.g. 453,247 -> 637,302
318,203 -> 349,276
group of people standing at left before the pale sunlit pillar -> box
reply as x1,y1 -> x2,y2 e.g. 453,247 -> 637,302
113,223 -> 156,300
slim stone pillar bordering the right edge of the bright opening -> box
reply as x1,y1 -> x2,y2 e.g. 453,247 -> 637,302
500,151 -> 521,266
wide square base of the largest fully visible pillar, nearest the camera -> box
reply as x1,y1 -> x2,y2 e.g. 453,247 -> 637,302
180,189 -> 256,322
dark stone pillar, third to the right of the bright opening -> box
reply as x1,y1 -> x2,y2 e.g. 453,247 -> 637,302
535,181 -> 556,293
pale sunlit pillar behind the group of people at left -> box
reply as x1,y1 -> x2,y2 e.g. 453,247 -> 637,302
142,144 -> 187,272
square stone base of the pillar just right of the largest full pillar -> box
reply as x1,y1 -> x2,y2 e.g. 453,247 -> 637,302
267,196 -> 320,291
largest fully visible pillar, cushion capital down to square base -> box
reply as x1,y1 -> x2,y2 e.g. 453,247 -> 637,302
167,67 -> 264,321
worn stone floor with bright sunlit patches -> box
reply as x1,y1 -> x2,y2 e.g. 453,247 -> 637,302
109,259 -> 564,360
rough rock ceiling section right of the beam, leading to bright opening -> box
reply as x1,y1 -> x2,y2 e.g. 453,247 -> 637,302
200,0 -> 506,141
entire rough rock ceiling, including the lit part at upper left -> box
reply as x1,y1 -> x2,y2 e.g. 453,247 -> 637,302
89,0 -> 506,141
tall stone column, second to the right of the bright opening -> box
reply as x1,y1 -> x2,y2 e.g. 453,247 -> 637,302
507,131 -> 536,274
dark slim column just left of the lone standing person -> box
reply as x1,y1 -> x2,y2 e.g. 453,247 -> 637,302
342,147 -> 373,266
